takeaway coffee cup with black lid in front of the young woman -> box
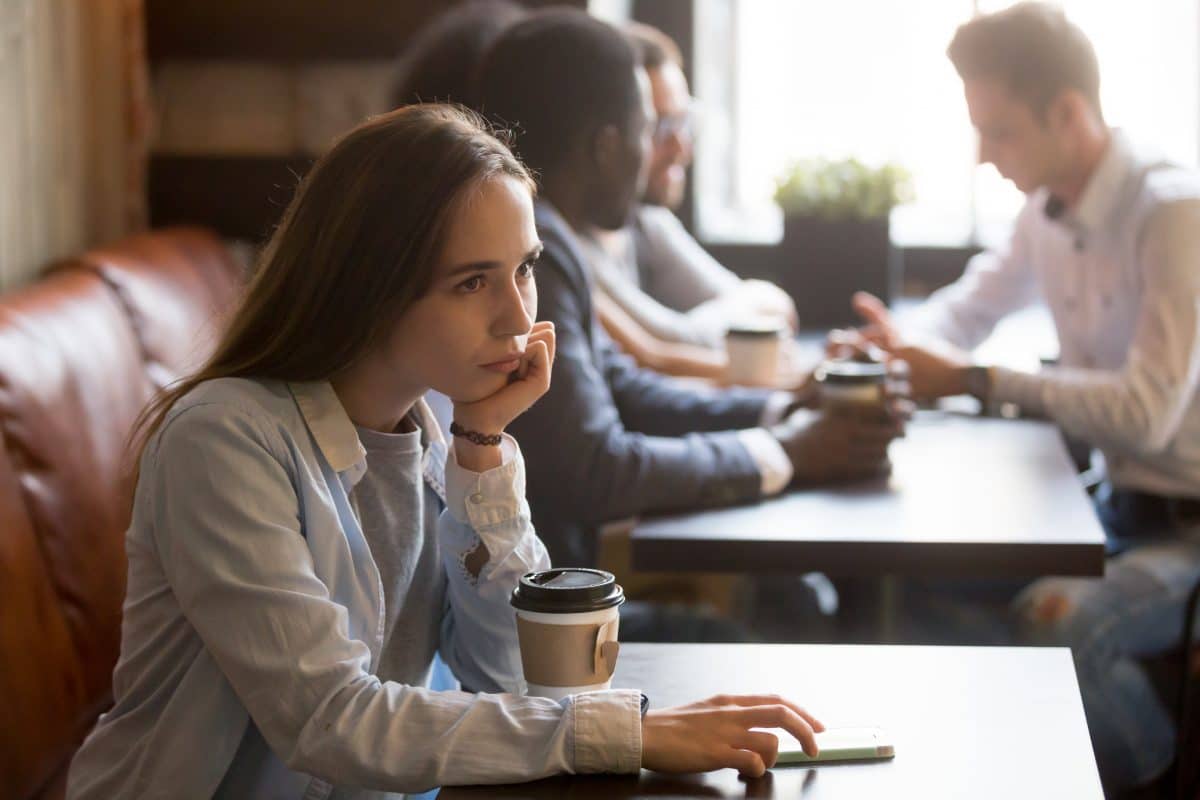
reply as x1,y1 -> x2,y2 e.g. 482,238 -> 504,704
510,567 -> 625,700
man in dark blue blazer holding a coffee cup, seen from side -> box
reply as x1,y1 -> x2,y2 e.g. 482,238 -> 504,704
476,10 -> 904,638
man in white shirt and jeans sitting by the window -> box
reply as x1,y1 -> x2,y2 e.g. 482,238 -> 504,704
856,4 -> 1200,792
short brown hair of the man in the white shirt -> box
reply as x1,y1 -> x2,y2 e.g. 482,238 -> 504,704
946,2 -> 1102,120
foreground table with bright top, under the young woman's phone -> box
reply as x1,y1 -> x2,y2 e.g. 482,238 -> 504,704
439,644 -> 1103,800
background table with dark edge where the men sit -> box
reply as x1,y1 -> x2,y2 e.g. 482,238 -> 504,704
632,411 -> 1104,577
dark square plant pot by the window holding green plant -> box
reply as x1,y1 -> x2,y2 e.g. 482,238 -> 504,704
776,216 -> 902,329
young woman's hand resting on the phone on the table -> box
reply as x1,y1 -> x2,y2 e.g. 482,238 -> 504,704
642,694 -> 824,777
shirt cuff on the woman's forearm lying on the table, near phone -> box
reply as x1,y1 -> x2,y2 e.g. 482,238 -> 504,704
571,690 -> 642,772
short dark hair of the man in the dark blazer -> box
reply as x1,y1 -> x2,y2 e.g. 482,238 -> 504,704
475,8 -> 641,174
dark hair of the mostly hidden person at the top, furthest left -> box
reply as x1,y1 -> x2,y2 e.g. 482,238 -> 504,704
389,0 -> 529,108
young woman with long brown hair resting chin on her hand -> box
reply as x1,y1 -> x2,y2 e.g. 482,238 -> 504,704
68,106 -> 821,800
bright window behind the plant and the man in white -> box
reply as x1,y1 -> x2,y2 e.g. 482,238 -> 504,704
695,0 -> 1200,245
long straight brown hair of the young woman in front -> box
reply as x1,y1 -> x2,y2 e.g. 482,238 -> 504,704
131,104 -> 533,469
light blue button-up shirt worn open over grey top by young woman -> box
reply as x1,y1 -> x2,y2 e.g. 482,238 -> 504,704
67,379 -> 641,800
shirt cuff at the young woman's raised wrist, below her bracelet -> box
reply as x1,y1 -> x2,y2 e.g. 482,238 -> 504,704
446,433 -> 528,530
